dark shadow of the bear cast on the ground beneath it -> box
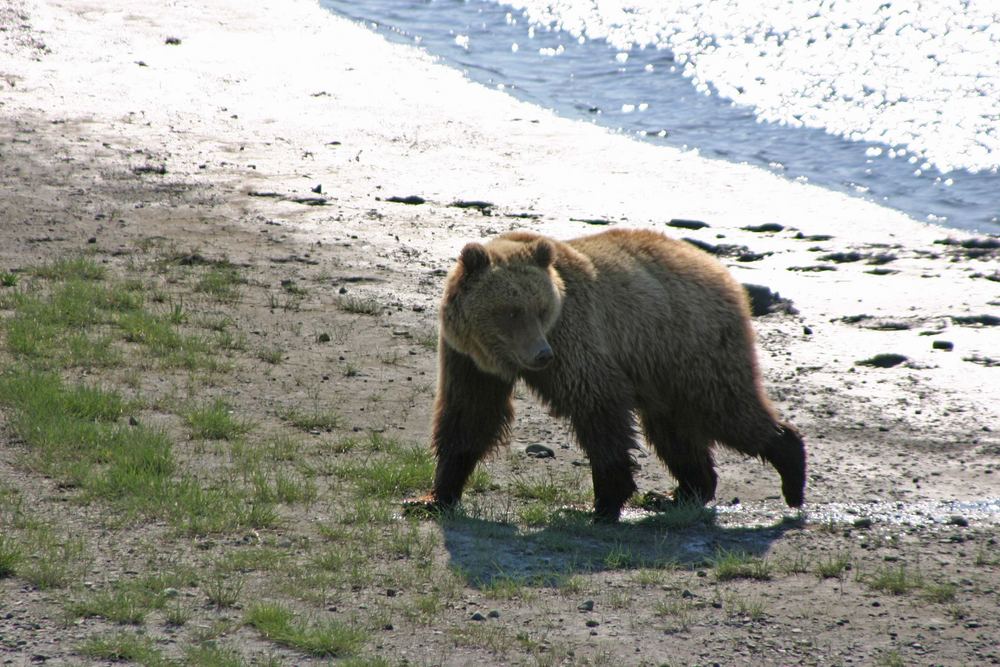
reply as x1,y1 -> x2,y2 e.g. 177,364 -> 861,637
438,510 -> 804,589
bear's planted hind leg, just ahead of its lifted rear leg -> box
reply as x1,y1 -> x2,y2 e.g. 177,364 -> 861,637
642,411 -> 718,505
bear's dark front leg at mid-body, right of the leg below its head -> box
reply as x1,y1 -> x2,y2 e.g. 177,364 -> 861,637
572,407 -> 636,523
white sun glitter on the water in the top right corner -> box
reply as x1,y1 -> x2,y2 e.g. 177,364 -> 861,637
497,0 -> 1000,173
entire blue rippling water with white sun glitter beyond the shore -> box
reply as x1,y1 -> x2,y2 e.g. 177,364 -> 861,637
321,0 -> 1000,233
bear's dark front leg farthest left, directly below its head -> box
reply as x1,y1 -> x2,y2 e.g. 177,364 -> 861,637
427,340 -> 514,507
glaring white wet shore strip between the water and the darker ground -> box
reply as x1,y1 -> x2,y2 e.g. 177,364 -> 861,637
2,0 -> 1000,417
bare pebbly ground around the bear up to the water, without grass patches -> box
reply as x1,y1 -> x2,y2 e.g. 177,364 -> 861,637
0,0 -> 1000,665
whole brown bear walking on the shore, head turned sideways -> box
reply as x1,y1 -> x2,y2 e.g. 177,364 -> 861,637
421,229 -> 806,521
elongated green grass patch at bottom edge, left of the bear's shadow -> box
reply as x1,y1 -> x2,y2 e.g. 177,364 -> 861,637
244,603 -> 368,658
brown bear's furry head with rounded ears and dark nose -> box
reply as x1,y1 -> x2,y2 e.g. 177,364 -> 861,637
441,238 -> 564,380
